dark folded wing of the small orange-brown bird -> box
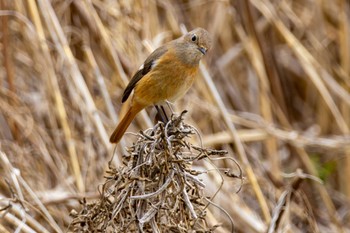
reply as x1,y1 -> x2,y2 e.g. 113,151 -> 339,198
122,46 -> 168,103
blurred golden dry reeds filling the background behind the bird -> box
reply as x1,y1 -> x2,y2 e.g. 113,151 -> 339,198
0,0 -> 350,233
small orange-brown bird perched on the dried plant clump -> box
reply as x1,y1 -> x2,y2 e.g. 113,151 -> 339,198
109,28 -> 211,143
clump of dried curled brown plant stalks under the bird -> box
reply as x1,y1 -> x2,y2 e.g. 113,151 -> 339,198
71,111 -> 234,232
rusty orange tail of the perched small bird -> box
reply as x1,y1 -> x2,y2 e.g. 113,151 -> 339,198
109,104 -> 144,143
